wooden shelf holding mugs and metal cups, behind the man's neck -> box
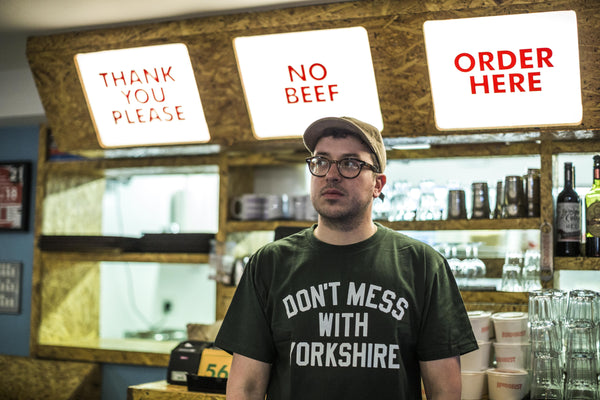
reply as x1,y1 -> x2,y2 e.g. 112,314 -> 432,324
226,218 -> 541,232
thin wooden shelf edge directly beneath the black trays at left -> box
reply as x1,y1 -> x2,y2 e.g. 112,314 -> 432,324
42,251 -> 209,264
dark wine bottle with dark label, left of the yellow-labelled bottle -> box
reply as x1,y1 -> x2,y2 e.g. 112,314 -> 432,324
556,162 -> 581,257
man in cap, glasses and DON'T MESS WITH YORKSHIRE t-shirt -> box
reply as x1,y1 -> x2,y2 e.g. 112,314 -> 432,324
216,117 -> 477,400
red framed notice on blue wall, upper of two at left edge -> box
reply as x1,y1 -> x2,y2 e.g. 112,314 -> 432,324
0,162 -> 31,231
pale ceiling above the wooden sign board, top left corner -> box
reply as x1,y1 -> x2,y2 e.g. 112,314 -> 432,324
0,0 -> 348,70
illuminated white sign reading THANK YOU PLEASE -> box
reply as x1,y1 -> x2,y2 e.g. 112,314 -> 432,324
75,43 -> 210,147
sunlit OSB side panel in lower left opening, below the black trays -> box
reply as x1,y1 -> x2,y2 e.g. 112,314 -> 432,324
38,256 -> 100,344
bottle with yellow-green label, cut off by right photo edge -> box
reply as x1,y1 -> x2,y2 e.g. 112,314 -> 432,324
585,155 -> 600,257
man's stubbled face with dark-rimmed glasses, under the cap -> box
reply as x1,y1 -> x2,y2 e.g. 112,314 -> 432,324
311,135 -> 385,222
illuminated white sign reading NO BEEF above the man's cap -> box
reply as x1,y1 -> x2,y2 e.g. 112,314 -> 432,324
234,27 -> 383,138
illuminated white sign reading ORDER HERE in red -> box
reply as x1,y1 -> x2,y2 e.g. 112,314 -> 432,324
424,11 -> 583,130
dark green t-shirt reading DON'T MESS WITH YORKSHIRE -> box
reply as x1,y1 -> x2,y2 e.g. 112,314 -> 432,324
216,224 -> 477,400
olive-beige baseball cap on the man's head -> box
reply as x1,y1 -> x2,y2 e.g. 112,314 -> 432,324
303,117 -> 386,172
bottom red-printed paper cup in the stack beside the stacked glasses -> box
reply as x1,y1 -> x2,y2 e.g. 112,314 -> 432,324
487,368 -> 529,400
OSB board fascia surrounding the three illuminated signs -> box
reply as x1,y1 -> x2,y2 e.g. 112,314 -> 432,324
27,0 -> 600,151
